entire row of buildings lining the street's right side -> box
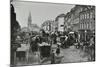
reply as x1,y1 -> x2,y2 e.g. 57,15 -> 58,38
42,5 -> 95,39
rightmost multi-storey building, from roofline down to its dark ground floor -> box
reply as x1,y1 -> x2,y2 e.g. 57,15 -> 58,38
79,6 -> 95,40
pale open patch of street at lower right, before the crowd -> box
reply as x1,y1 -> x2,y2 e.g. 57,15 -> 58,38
62,46 -> 88,63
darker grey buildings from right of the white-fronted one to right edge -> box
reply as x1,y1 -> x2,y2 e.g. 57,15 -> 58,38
64,5 -> 95,40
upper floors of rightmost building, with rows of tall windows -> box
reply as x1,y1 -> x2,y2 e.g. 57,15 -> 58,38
80,7 -> 95,30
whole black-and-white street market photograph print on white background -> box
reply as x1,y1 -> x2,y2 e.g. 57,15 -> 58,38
10,0 -> 95,67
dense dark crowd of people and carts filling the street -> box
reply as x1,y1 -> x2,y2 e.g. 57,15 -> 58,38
10,31 -> 95,64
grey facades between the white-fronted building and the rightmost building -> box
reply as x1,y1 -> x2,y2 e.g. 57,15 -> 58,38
64,5 -> 83,31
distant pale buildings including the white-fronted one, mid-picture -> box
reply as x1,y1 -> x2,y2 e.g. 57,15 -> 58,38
41,14 -> 65,32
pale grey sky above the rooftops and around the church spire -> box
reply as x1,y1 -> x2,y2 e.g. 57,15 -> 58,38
12,1 -> 75,27
